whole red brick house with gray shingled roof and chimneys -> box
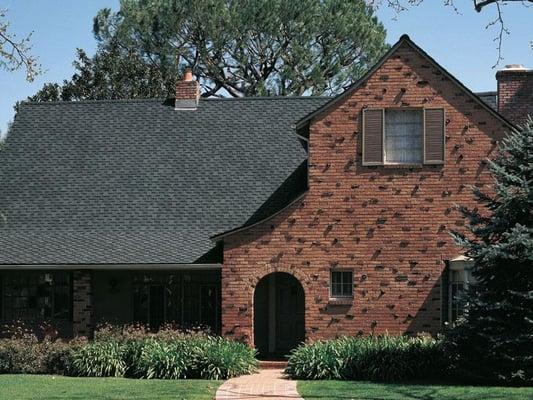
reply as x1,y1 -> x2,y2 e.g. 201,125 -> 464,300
0,35 -> 533,355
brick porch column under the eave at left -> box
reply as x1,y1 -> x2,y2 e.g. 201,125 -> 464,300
72,270 -> 93,337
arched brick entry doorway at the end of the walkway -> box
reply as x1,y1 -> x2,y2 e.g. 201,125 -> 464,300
254,272 -> 305,359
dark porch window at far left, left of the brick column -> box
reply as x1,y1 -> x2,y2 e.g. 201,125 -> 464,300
0,271 -> 71,320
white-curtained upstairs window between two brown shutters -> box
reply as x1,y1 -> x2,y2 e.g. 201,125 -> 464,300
385,110 -> 424,163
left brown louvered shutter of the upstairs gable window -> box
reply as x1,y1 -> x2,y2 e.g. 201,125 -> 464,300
363,109 -> 383,165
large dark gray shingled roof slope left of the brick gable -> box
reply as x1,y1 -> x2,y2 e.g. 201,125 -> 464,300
0,97 -> 328,264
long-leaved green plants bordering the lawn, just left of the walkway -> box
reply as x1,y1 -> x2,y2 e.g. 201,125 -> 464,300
68,325 -> 257,379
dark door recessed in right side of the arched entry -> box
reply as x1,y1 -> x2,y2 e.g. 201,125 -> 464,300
276,274 -> 305,354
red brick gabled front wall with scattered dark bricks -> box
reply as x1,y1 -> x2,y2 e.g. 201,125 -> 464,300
222,43 -> 508,343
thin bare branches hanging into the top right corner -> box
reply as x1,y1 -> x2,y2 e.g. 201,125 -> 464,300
369,0 -> 533,68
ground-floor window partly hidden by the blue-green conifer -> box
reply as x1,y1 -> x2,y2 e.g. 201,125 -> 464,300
446,259 -> 474,325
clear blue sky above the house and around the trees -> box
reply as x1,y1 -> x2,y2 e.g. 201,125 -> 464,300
0,0 -> 533,133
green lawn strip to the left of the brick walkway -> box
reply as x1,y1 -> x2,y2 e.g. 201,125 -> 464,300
0,375 -> 221,400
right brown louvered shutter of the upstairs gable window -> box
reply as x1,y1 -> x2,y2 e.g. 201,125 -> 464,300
424,108 -> 444,164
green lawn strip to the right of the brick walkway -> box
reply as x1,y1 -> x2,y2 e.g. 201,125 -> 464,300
298,381 -> 533,400
